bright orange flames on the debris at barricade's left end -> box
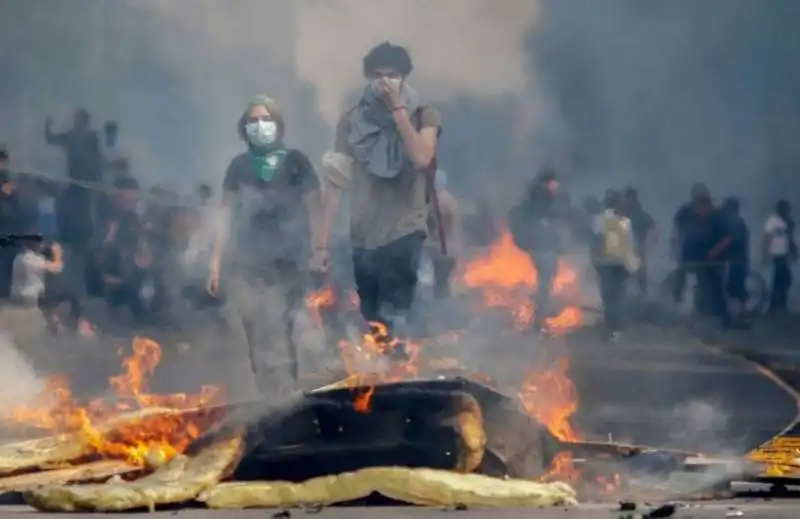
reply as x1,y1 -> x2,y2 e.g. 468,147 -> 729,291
2,337 -> 224,466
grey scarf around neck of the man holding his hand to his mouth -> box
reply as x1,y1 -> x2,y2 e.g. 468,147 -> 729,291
347,82 -> 420,178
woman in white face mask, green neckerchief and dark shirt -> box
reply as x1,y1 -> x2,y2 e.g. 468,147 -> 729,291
207,96 -> 327,394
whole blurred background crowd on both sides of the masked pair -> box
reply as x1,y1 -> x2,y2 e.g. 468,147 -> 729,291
0,102 -> 798,350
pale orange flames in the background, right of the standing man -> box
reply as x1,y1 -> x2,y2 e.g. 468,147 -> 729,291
463,228 -> 583,333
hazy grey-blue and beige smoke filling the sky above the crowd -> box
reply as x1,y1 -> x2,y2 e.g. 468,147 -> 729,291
0,0 -> 800,212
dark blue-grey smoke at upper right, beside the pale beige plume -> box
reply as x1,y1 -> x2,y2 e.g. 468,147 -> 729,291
530,0 -> 800,221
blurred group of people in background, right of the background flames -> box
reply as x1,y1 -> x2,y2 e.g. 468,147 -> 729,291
509,170 -> 798,338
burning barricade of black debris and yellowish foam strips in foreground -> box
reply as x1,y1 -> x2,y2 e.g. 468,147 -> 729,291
0,330 -> 574,511
